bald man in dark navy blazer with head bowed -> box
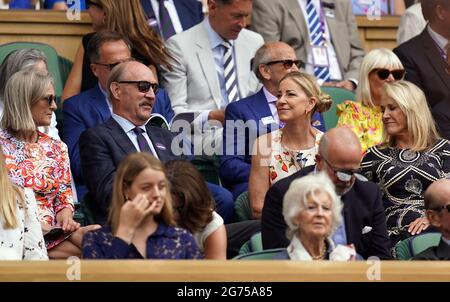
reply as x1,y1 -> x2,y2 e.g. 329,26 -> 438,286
261,127 -> 391,259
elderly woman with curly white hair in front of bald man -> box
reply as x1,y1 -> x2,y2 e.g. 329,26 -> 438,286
274,172 -> 356,261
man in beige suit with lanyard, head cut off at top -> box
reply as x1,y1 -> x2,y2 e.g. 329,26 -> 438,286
251,0 -> 364,90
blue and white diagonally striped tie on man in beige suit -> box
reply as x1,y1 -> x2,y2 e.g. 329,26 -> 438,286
306,0 -> 331,82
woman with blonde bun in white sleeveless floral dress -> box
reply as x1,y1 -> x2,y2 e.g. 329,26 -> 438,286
249,72 -> 332,218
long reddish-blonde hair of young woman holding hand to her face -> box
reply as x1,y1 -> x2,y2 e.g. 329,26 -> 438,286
108,152 -> 175,233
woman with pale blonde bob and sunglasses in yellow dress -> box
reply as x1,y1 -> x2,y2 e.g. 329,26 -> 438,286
336,48 -> 405,153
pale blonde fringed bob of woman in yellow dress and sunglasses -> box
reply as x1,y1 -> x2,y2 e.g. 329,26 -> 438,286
356,48 -> 404,107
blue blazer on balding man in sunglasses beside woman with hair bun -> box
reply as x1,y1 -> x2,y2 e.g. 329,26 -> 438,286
219,88 -> 325,196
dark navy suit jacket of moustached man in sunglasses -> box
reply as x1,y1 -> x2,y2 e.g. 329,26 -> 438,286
80,117 -> 180,224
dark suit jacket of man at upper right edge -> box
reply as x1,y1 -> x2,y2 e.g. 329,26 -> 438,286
393,28 -> 450,109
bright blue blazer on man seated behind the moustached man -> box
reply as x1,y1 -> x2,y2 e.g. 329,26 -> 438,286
62,85 -> 174,200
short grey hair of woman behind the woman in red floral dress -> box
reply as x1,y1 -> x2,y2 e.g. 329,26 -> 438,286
0,48 -> 47,98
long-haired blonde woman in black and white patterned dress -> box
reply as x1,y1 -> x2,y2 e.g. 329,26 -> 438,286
361,81 -> 450,250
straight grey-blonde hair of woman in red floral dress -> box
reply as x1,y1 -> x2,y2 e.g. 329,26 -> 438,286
0,70 -> 53,135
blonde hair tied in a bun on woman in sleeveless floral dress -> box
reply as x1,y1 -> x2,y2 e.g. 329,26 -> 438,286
280,71 -> 333,115
